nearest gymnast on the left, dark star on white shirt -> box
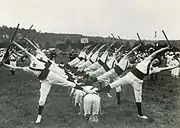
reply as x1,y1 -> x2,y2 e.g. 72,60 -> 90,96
4,42 -> 95,123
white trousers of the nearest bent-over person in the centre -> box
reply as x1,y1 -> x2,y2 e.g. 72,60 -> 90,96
84,94 -> 101,116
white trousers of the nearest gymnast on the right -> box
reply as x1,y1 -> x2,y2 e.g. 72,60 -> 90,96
110,72 -> 143,102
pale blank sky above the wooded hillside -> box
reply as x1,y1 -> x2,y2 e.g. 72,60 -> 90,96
0,0 -> 180,40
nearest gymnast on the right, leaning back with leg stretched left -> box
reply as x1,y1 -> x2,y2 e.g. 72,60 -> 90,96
96,46 -> 179,119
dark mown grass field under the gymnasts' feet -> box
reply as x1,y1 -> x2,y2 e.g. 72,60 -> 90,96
0,54 -> 180,128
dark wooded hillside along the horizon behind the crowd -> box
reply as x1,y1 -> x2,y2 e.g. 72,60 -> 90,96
0,25 -> 180,51
